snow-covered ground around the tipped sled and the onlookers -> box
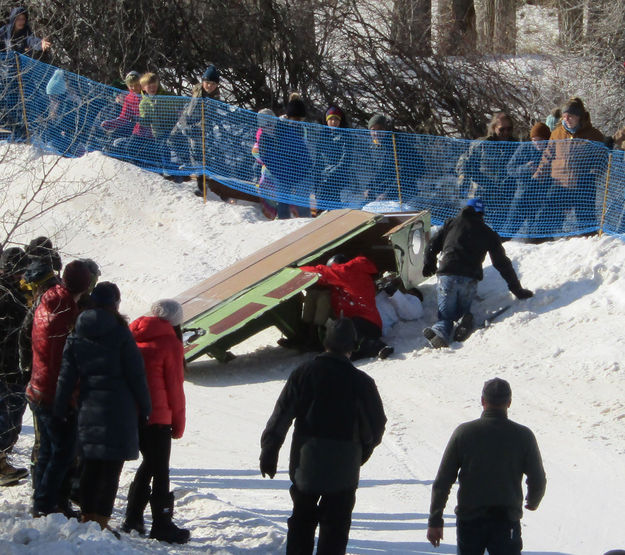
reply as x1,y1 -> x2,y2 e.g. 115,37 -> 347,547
0,147 -> 625,555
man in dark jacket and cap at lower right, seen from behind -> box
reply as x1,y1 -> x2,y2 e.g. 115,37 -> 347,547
427,378 -> 547,555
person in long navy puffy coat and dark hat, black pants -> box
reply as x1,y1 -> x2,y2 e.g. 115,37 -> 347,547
54,281 -> 151,529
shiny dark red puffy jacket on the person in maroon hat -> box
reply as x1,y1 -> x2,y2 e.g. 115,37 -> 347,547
26,284 -> 78,406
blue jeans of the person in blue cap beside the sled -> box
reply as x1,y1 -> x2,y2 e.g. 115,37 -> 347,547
432,276 -> 477,344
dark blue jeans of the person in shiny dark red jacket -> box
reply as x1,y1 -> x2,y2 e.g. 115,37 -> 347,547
31,403 -> 77,513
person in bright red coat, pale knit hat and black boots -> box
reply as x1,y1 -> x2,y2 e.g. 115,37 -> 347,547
122,299 -> 190,543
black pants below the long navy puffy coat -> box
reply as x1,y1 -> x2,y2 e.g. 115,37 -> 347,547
80,459 -> 124,517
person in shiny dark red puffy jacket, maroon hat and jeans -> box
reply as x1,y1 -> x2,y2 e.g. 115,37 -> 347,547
26,260 -> 91,516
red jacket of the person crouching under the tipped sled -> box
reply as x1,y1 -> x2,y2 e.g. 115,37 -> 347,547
301,256 -> 382,329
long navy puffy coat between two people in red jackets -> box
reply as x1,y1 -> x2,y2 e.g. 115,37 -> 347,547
54,308 -> 150,461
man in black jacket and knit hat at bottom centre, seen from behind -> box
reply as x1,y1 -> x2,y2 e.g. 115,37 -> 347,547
260,318 -> 386,554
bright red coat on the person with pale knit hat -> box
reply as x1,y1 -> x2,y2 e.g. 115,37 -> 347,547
130,316 -> 185,439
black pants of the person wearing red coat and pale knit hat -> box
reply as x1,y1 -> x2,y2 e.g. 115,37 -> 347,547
133,424 -> 171,506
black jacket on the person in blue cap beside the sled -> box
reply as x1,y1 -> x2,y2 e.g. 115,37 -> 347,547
423,207 -> 521,293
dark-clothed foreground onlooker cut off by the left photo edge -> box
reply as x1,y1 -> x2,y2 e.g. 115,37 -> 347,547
0,247 -> 28,486
